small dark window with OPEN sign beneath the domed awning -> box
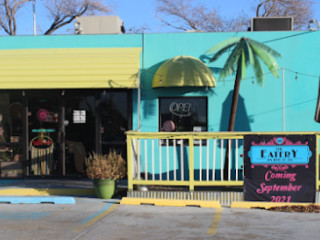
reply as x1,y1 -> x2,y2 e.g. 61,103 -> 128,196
159,97 -> 208,132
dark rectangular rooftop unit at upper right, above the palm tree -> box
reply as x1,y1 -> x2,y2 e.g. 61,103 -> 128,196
251,17 -> 293,31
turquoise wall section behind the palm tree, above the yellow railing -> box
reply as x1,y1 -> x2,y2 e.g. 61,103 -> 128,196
133,31 -> 320,132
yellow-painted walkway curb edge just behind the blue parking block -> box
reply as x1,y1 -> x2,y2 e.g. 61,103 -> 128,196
0,188 -> 96,196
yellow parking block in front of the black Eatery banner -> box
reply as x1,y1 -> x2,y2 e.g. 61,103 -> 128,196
230,201 -> 320,209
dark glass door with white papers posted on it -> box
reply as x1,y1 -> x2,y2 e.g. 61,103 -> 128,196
64,90 -> 96,176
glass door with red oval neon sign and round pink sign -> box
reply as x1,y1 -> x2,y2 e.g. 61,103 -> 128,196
28,91 -> 61,176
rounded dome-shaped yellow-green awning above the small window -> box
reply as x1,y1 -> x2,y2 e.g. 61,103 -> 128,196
152,56 -> 216,88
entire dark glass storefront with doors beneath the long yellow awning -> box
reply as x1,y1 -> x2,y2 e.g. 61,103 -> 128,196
0,90 -> 132,177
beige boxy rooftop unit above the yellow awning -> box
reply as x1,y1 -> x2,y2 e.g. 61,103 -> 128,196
74,16 -> 125,34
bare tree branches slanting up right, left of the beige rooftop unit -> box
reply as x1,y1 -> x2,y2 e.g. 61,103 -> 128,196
44,0 -> 112,35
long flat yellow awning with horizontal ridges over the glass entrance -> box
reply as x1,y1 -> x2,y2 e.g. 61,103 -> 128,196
0,48 -> 141,89
